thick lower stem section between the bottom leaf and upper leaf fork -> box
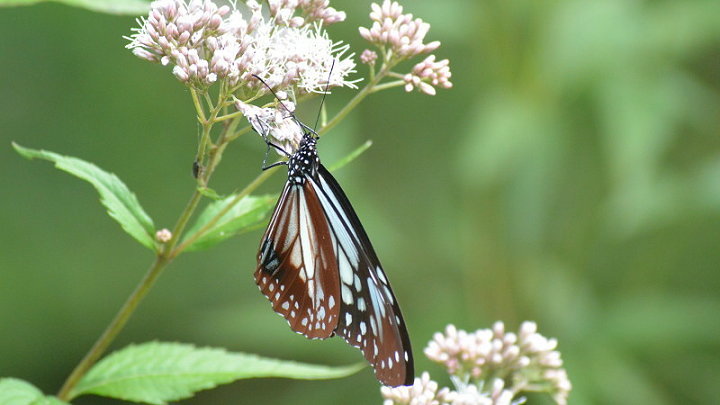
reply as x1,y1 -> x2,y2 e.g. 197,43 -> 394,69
57,256 -> 169,401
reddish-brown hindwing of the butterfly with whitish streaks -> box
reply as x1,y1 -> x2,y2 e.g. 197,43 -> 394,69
255,183 -> 340,339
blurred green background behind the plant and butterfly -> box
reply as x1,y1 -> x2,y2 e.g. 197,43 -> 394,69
0,0 -> 720,405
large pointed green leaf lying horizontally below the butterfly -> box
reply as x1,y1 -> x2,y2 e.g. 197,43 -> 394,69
70,342 -> 364,405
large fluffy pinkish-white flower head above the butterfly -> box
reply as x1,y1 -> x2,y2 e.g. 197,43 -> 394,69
127,0 -> 355,93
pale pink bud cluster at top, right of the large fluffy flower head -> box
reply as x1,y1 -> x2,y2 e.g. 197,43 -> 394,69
359,0 -> 440,59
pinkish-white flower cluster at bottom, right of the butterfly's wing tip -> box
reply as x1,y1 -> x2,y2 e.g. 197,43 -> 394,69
425,322 -> 572,405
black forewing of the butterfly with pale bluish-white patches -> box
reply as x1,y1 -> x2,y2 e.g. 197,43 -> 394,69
308,165 -> 414,386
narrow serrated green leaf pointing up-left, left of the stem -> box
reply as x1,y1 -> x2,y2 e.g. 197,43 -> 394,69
12,142 -> 155,250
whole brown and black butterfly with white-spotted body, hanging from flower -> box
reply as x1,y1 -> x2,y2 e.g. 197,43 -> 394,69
255,116 -> 414,386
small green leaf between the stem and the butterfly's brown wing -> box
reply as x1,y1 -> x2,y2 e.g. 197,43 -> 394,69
183,195 -> 277,251
